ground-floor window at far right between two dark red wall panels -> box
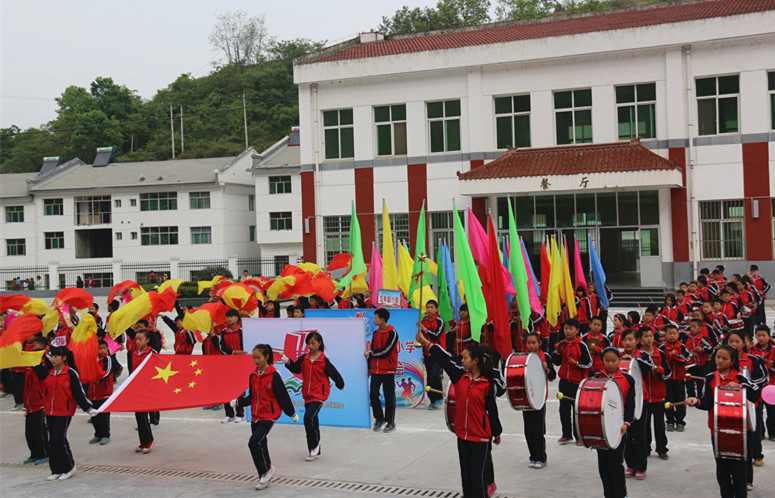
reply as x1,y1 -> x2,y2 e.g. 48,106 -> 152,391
700,200 -> 745,259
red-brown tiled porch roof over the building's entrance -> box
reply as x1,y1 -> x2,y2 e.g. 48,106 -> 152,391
459,140 -> 676,180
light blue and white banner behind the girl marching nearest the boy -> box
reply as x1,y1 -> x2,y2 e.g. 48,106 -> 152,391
242,320 -> 371,427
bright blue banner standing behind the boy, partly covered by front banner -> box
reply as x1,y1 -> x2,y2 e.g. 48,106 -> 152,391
305,309 -> 425,413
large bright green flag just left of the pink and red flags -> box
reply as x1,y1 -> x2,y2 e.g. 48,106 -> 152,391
452,203 -> 487,341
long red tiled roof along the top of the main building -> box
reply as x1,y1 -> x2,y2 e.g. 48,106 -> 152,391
310,0 -> 775,63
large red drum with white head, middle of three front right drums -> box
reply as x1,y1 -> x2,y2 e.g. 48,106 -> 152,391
576,378 -> 624,450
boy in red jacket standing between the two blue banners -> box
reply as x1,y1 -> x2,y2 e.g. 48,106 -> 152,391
364,308 -> 398,432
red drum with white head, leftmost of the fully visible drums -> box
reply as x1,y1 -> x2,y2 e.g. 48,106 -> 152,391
506,353 -> 549,410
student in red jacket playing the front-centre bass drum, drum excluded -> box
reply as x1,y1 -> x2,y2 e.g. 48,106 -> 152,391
595,347 -> 635,498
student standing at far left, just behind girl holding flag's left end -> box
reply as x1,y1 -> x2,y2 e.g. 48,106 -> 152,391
24,334 -> 51,465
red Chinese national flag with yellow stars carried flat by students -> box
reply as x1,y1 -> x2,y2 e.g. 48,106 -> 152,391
98,354 -> 256,412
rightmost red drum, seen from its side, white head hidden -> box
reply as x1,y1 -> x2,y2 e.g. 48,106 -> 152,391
713,386 -> 748,460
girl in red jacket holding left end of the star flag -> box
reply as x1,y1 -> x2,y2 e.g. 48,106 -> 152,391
43,346 -> 97,481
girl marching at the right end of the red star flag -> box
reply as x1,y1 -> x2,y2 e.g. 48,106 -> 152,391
230,344 -> 299,489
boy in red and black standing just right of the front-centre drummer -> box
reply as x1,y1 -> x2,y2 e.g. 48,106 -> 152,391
639,328 -> 671,460
